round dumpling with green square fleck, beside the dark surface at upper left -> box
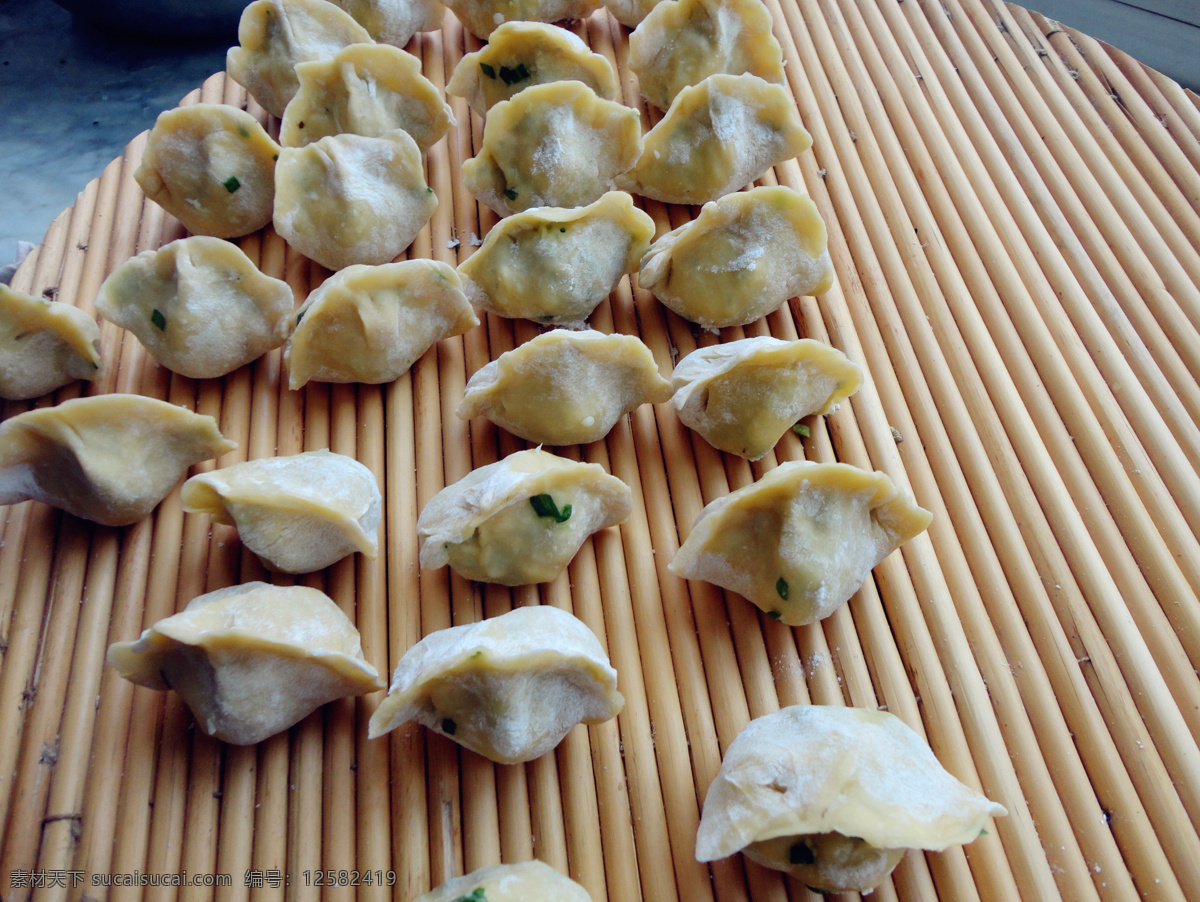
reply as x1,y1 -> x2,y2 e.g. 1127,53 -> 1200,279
133,103 -> 280,237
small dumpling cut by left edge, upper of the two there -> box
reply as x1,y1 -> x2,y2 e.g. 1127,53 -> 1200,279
0,284 -> 101,401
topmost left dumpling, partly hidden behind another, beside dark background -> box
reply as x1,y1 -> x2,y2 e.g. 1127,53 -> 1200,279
226,0 -> 371,116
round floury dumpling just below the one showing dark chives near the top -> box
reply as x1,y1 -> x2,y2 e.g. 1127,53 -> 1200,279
462,82 -> 642,216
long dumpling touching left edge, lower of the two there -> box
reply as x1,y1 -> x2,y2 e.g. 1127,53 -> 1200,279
0,395 -> 238,527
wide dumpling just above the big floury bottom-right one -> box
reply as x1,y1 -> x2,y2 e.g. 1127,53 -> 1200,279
668,461 -> 932,626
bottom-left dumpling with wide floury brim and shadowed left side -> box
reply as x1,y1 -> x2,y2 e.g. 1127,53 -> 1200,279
108,583 -> 384,745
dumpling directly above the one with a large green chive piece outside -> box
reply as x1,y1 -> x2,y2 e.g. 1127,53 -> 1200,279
457,329 -> 673,445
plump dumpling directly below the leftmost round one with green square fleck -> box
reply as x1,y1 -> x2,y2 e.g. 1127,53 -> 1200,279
96,235 -> 293,379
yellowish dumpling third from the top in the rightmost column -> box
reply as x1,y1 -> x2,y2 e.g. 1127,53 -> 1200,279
637,186 -> 833,329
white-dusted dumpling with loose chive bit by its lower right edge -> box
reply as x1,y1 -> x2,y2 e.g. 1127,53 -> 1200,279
671,336 -> 863,461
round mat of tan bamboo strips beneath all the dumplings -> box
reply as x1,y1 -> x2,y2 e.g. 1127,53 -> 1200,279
0,0 -> 1200,902
